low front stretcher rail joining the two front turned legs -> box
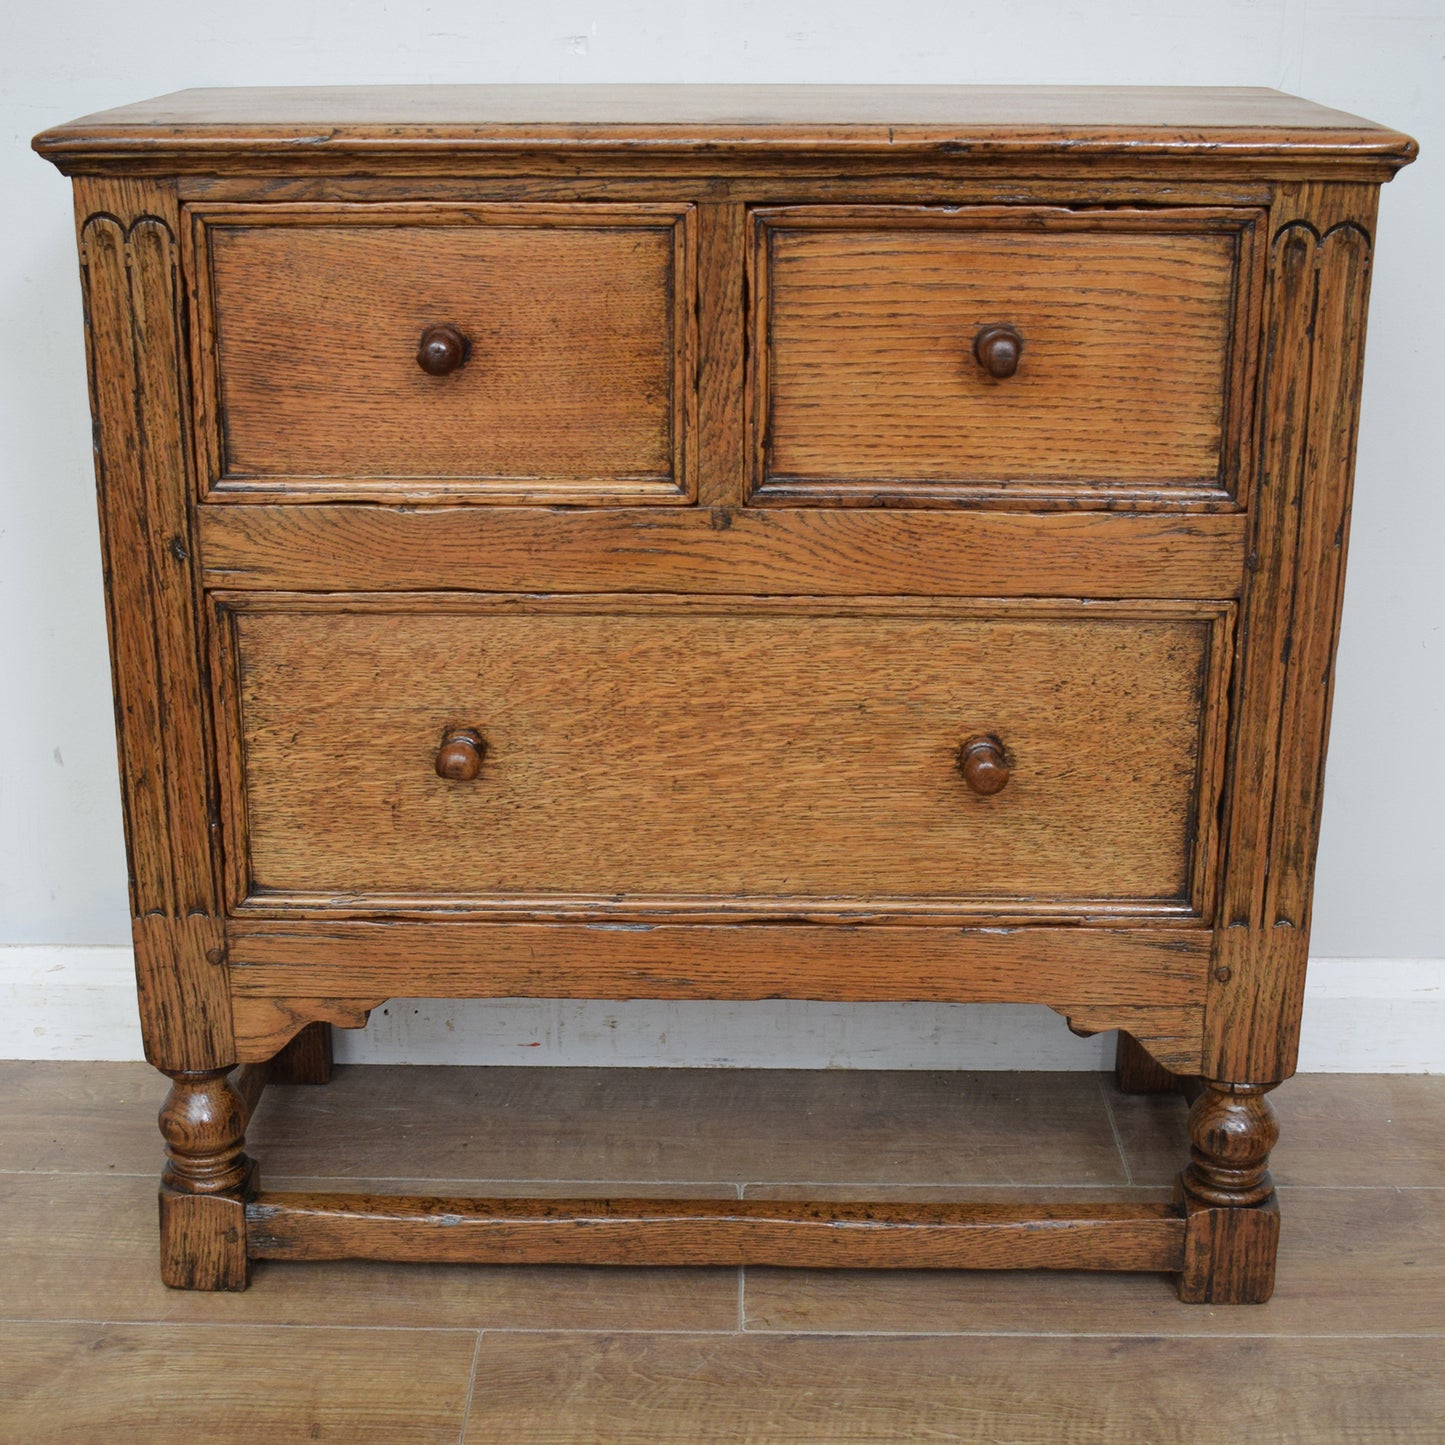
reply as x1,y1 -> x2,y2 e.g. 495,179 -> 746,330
246,1194 -> 1185,1270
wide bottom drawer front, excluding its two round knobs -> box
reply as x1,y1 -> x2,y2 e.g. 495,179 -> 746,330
215,594 -> 1233,916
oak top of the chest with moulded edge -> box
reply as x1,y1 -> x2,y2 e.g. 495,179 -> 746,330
36,85 -> 1415,179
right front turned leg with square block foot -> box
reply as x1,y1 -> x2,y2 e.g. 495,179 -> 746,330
1175,1081 -> 1279,1305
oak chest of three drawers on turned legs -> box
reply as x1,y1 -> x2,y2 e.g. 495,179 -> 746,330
36,87 -> 1413,1303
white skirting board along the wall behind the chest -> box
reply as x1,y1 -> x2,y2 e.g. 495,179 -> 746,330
0,946 -> 1445,1074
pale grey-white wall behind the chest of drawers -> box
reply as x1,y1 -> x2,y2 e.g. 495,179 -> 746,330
0,0 -> 1445,1066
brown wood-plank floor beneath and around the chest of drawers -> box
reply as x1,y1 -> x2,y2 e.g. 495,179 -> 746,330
0,1062 -> 1445,1445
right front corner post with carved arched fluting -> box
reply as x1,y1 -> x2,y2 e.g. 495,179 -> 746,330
1208,186 -> 1376,1082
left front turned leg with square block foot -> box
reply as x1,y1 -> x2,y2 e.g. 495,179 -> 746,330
160,1069 -> 257,1290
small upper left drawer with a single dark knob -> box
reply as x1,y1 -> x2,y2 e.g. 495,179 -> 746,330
189,204 -> 694,504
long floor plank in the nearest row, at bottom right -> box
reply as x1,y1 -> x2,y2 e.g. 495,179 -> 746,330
465,1329 -> 1445,1445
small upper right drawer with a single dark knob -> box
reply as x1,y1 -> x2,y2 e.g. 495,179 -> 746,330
750,207 -> 1263,509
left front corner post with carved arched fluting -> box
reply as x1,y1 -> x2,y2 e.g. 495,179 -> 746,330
75,181 -> 234,1069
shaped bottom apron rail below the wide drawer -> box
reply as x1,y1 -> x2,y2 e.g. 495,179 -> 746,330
216,920 -> 1209,1074
